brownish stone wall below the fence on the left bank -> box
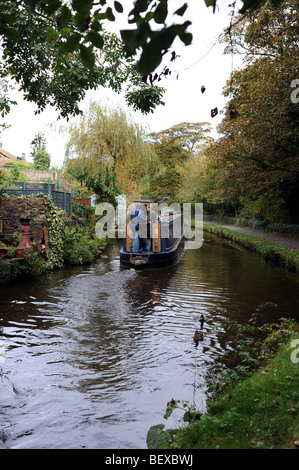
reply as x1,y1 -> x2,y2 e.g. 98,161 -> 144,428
0,197 -> 47,247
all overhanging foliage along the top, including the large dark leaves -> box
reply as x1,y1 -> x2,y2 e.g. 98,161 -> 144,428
0,0 -> 281,117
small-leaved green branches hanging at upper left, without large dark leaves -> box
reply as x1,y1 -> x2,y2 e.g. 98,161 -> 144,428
0,0 -> 164,118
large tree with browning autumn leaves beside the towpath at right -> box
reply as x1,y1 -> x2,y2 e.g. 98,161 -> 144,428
212,1 -> 299,222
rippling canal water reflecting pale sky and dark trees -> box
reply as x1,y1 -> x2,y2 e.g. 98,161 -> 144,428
0,234 -> 299,449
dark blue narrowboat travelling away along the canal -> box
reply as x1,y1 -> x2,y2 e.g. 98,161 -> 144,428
120,205 -> 185,269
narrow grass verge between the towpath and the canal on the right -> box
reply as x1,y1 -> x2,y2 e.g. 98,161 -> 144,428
203,225 -> 299,272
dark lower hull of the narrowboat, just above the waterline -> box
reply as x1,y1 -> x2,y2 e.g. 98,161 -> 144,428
120,237 -> 185,269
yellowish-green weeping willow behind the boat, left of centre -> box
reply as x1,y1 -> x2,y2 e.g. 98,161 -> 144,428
66,101 -> 159,200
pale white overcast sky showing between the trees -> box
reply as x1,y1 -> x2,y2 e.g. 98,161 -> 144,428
0,0 -> 241,167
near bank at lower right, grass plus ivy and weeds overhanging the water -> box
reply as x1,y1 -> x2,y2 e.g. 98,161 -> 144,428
147,312 -> 299,449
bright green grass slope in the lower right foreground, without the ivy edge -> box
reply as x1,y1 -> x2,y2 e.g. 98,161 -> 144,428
148,332 -> 299,449
